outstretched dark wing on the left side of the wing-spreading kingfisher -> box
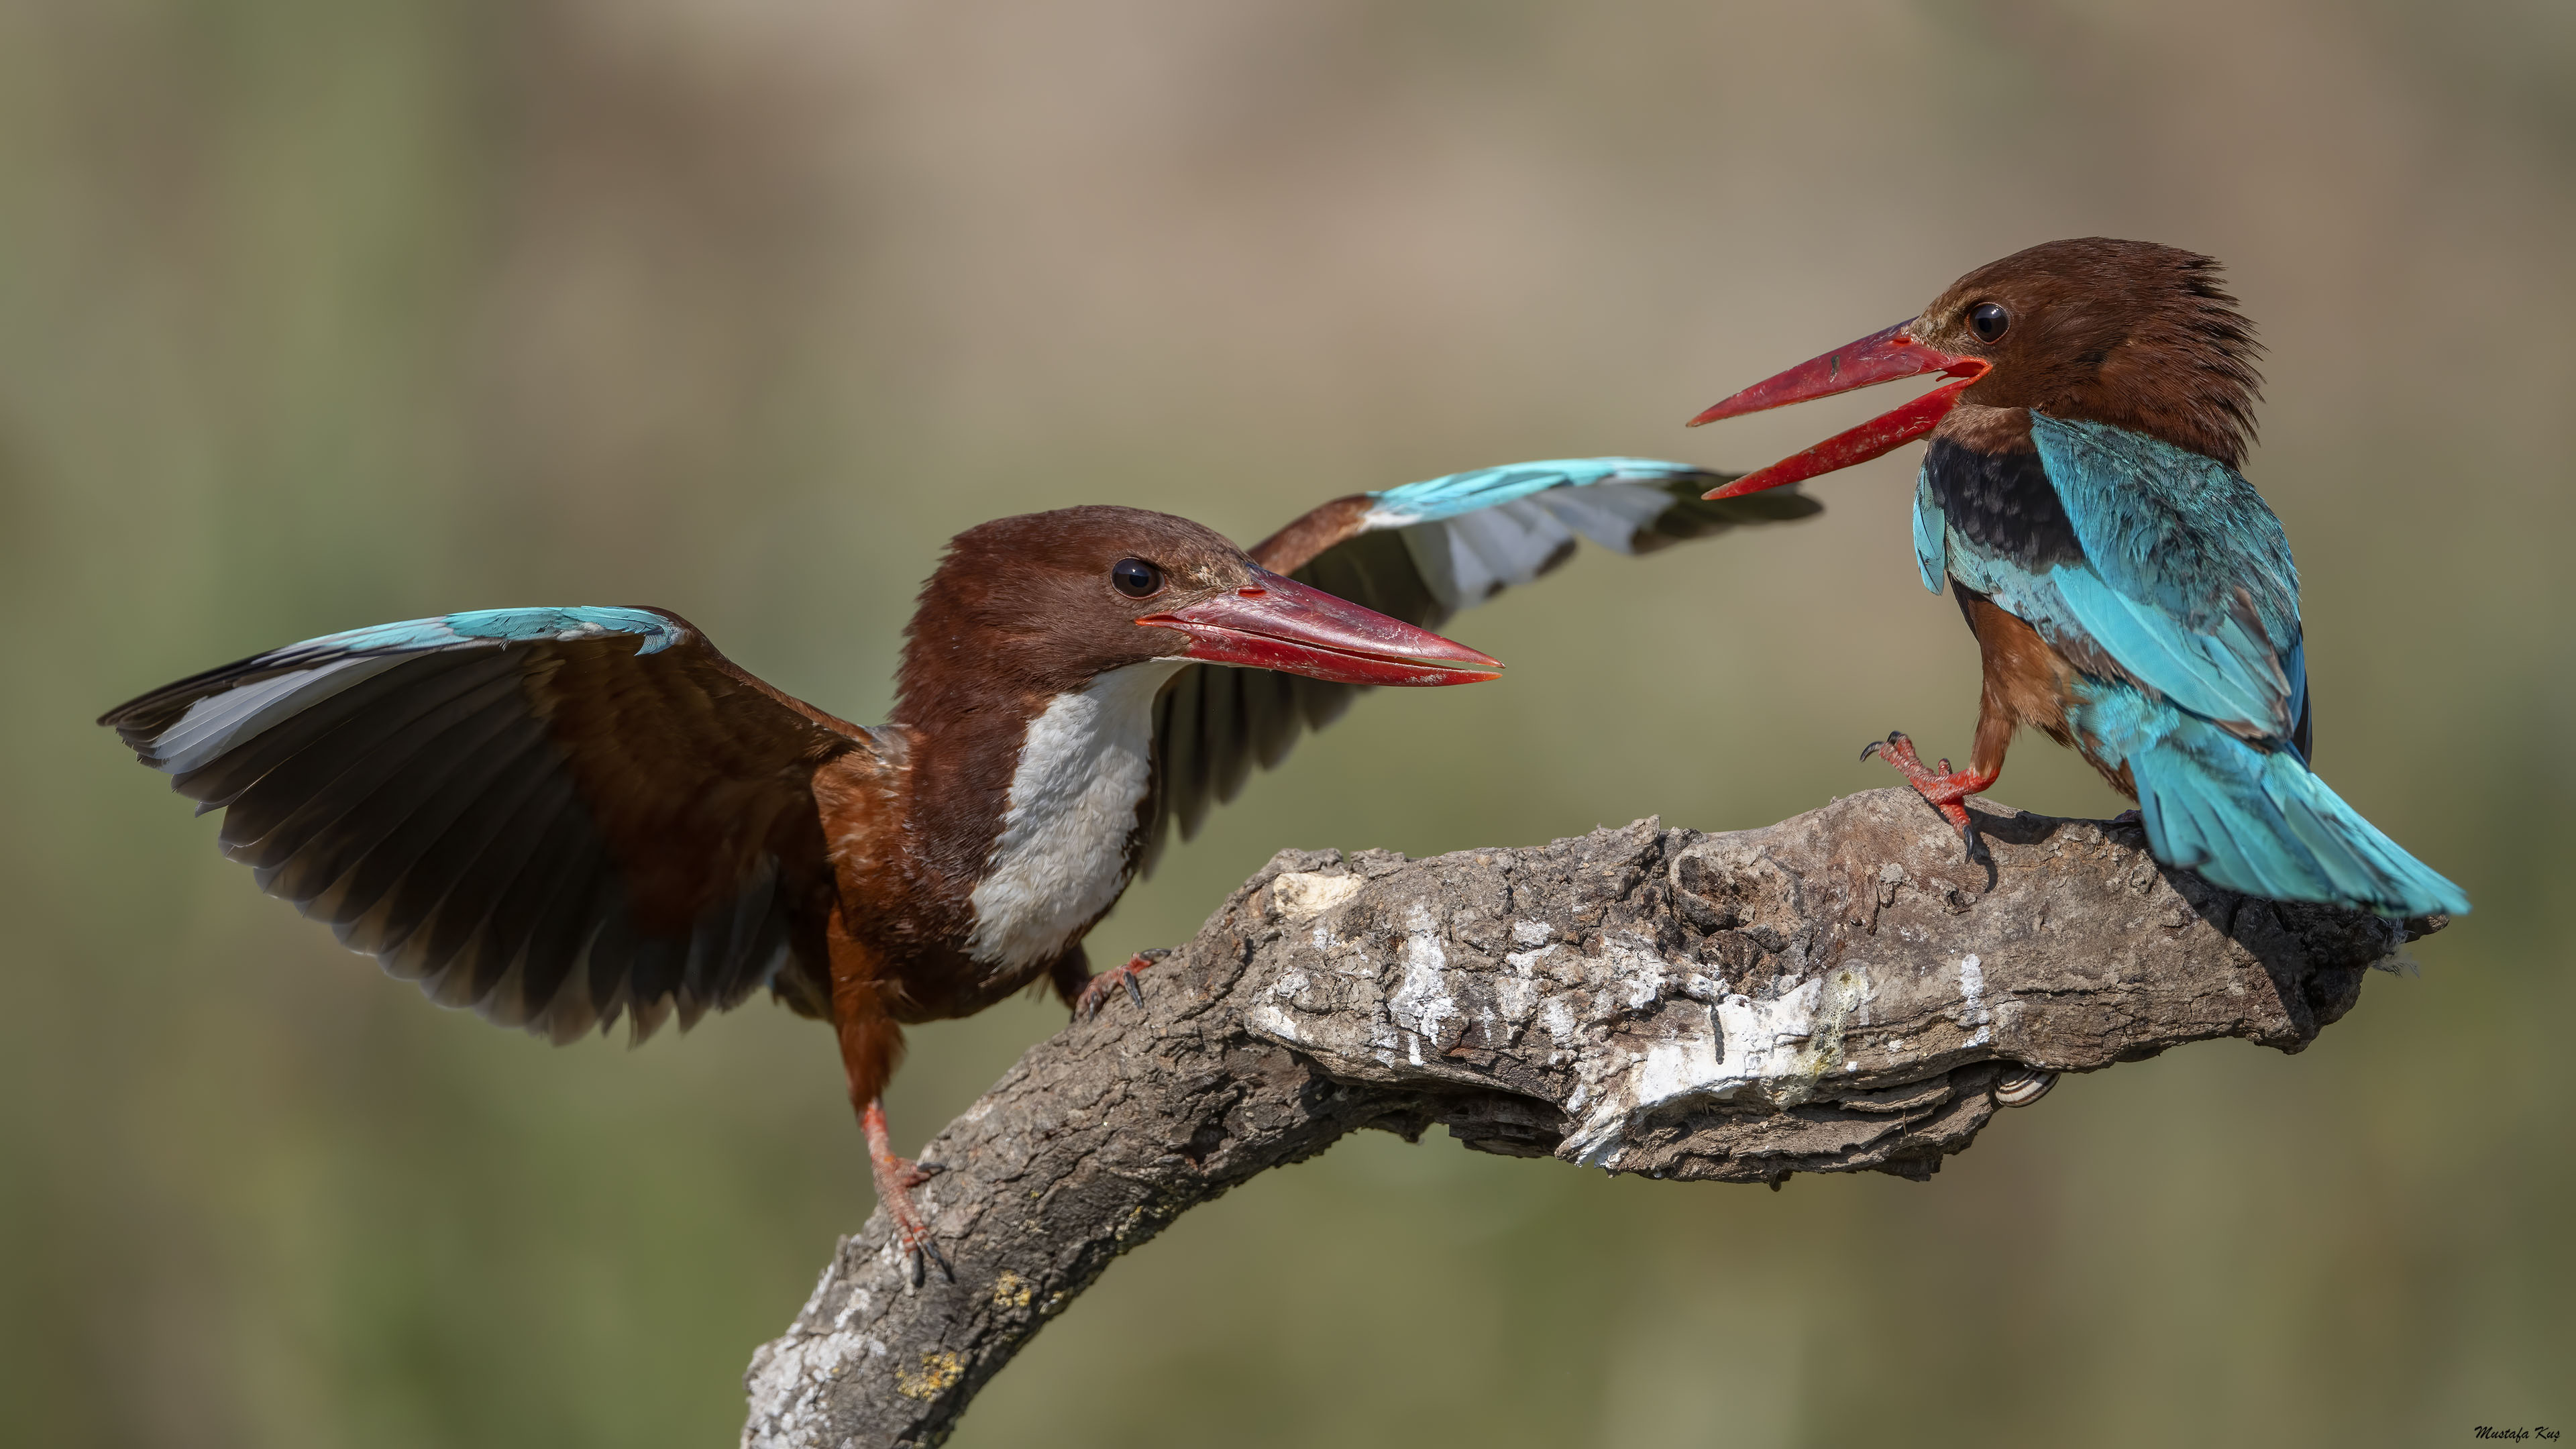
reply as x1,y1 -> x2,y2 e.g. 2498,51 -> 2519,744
101,608 -> 876,1042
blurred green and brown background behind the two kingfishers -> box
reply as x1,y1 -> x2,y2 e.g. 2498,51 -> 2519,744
0,0 -> 2576,1446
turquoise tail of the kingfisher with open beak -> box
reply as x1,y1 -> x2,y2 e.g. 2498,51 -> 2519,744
2128,716 -> 2468,918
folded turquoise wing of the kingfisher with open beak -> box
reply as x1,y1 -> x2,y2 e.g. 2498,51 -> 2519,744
1914,415 -> 2308,755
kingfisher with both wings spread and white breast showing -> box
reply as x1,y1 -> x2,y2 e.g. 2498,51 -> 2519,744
101,459 -> 1816,1281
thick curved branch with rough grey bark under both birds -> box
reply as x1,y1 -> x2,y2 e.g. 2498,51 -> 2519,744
742,789 -> 2442,1449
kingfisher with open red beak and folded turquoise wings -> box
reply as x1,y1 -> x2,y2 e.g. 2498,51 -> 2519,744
1693,237 -> 2468,918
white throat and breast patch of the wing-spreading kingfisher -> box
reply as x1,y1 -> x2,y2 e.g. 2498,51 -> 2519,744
966,660 -> 1187,969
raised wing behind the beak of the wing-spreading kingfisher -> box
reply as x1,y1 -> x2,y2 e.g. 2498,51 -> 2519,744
1146,459 -> 1824,869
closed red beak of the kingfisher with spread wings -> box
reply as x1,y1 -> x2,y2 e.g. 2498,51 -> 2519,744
1138,570 -> 1502,686
